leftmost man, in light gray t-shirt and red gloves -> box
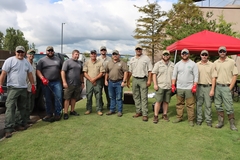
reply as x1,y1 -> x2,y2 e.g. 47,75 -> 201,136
0,46 -> 36,138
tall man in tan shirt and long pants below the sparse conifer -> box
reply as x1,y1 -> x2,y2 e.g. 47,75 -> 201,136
128,44 -> 152,122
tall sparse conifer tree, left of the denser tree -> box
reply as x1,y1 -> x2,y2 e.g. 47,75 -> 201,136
133,0 -> 166,63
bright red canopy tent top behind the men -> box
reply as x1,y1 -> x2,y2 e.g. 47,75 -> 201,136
167,30 -> 240,55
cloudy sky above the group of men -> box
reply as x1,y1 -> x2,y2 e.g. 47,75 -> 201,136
0,0 -> 232,54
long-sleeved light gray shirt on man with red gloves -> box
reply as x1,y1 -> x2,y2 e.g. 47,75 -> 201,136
172,59 -> 198,89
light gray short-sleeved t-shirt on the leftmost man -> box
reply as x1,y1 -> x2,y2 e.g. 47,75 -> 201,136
2,56 -> 33,88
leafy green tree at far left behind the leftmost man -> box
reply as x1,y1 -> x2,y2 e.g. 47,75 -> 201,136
3,28 -> 28,51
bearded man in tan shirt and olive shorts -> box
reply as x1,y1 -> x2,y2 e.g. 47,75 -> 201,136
152,50 -> 174,124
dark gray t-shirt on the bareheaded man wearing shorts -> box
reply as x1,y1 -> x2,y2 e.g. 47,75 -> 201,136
62,59 -> 83,85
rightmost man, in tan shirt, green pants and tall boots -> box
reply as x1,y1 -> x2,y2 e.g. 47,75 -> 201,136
214,46 -> 238,131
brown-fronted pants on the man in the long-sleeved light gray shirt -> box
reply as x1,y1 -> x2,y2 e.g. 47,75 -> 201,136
176,89 -> 195,121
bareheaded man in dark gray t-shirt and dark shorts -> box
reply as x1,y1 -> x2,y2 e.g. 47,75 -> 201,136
61,50 -> 84,120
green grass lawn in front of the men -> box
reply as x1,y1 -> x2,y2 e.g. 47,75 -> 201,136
0,89 -> 240,160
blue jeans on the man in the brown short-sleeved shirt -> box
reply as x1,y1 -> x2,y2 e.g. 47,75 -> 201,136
108,81 -> 123,112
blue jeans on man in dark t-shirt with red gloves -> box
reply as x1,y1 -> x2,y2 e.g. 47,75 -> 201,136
42,81 -> 62,116
